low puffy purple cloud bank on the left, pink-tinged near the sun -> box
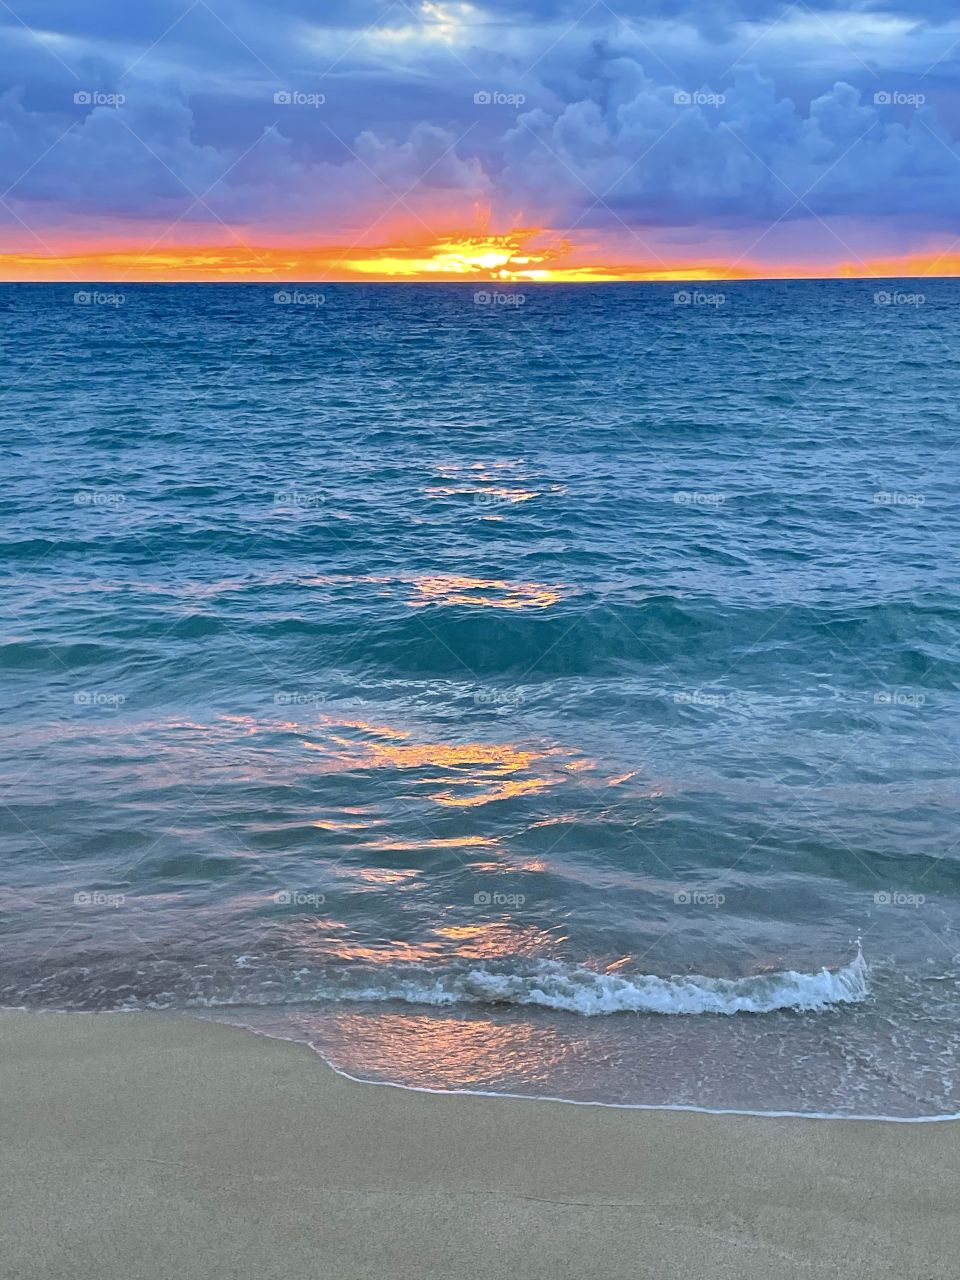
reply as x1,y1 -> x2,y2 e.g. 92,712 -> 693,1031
0,80 -> 489,239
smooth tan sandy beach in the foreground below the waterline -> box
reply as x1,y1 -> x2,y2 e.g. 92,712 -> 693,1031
0,1012 -> 960,1280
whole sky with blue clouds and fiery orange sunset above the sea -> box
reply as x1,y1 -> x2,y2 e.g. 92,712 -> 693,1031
0,0 -> 960,280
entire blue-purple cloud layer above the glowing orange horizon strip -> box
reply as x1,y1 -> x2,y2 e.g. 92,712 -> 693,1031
0,0 -> 960,241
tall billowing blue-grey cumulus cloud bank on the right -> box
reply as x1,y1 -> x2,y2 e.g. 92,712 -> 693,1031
500,60 -> 960,228
